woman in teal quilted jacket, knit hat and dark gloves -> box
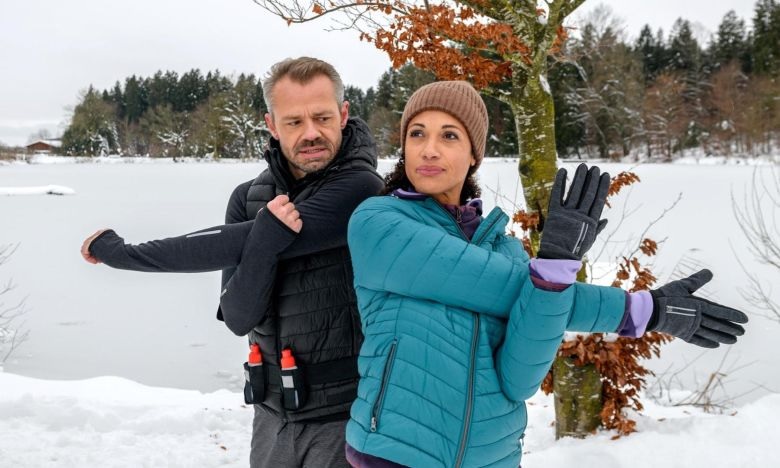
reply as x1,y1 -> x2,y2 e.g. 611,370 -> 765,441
346,81 -> 746,467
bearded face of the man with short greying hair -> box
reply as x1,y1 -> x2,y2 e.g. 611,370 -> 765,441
265,75 -> 349,179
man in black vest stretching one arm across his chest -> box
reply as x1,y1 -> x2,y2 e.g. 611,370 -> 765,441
82,57 -> 383,467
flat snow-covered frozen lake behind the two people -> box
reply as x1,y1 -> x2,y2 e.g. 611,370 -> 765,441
0,160 -> 780,400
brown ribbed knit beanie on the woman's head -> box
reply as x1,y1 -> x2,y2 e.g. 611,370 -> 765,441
401,81 -> 488,167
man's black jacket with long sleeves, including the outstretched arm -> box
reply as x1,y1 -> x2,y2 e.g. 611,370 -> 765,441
90,119 -> 382,421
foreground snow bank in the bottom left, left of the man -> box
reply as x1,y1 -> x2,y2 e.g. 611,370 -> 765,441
0,373 -> 253,468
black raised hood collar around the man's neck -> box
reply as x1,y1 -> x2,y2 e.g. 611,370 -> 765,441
263,117 -> 377,191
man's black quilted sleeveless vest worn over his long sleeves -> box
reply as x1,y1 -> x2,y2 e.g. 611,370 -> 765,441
246,135 -> 374,421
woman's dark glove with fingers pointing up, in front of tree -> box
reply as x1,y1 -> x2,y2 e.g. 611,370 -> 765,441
538,164 -> 609,260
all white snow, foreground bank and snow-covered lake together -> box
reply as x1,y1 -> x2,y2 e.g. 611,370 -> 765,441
0,160 -> 780,468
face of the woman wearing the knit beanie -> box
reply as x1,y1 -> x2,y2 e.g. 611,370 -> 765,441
404,110 -> 476,205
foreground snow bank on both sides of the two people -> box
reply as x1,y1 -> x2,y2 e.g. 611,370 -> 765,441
0,373 -> 780,468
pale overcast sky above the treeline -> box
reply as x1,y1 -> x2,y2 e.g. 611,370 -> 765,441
0,0 -> 755,144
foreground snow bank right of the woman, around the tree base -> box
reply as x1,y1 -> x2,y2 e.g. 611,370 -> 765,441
522,393 -> 780,468
